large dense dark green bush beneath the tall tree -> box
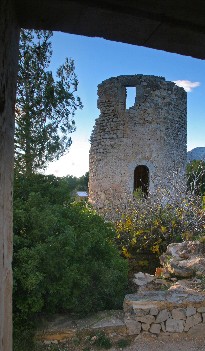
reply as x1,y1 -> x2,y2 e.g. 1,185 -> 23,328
13,174 -> 127,326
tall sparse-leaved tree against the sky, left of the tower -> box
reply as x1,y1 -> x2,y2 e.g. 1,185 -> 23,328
15,30 -> 82,174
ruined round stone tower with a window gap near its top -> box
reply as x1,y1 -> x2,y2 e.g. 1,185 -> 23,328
89,75 -> 187,211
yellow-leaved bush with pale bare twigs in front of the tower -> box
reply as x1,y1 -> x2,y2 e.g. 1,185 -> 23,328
115,170 -> 205,265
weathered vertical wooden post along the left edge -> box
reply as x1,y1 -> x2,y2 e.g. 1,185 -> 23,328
0,0 -> 19,351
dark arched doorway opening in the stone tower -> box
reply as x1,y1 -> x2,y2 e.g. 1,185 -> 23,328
134,165 -> 149,197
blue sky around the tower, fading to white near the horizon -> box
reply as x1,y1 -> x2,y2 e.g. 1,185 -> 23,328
46,32 -> 205,177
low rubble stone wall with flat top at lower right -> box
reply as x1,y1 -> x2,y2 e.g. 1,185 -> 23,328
124,291 -> 205,335
